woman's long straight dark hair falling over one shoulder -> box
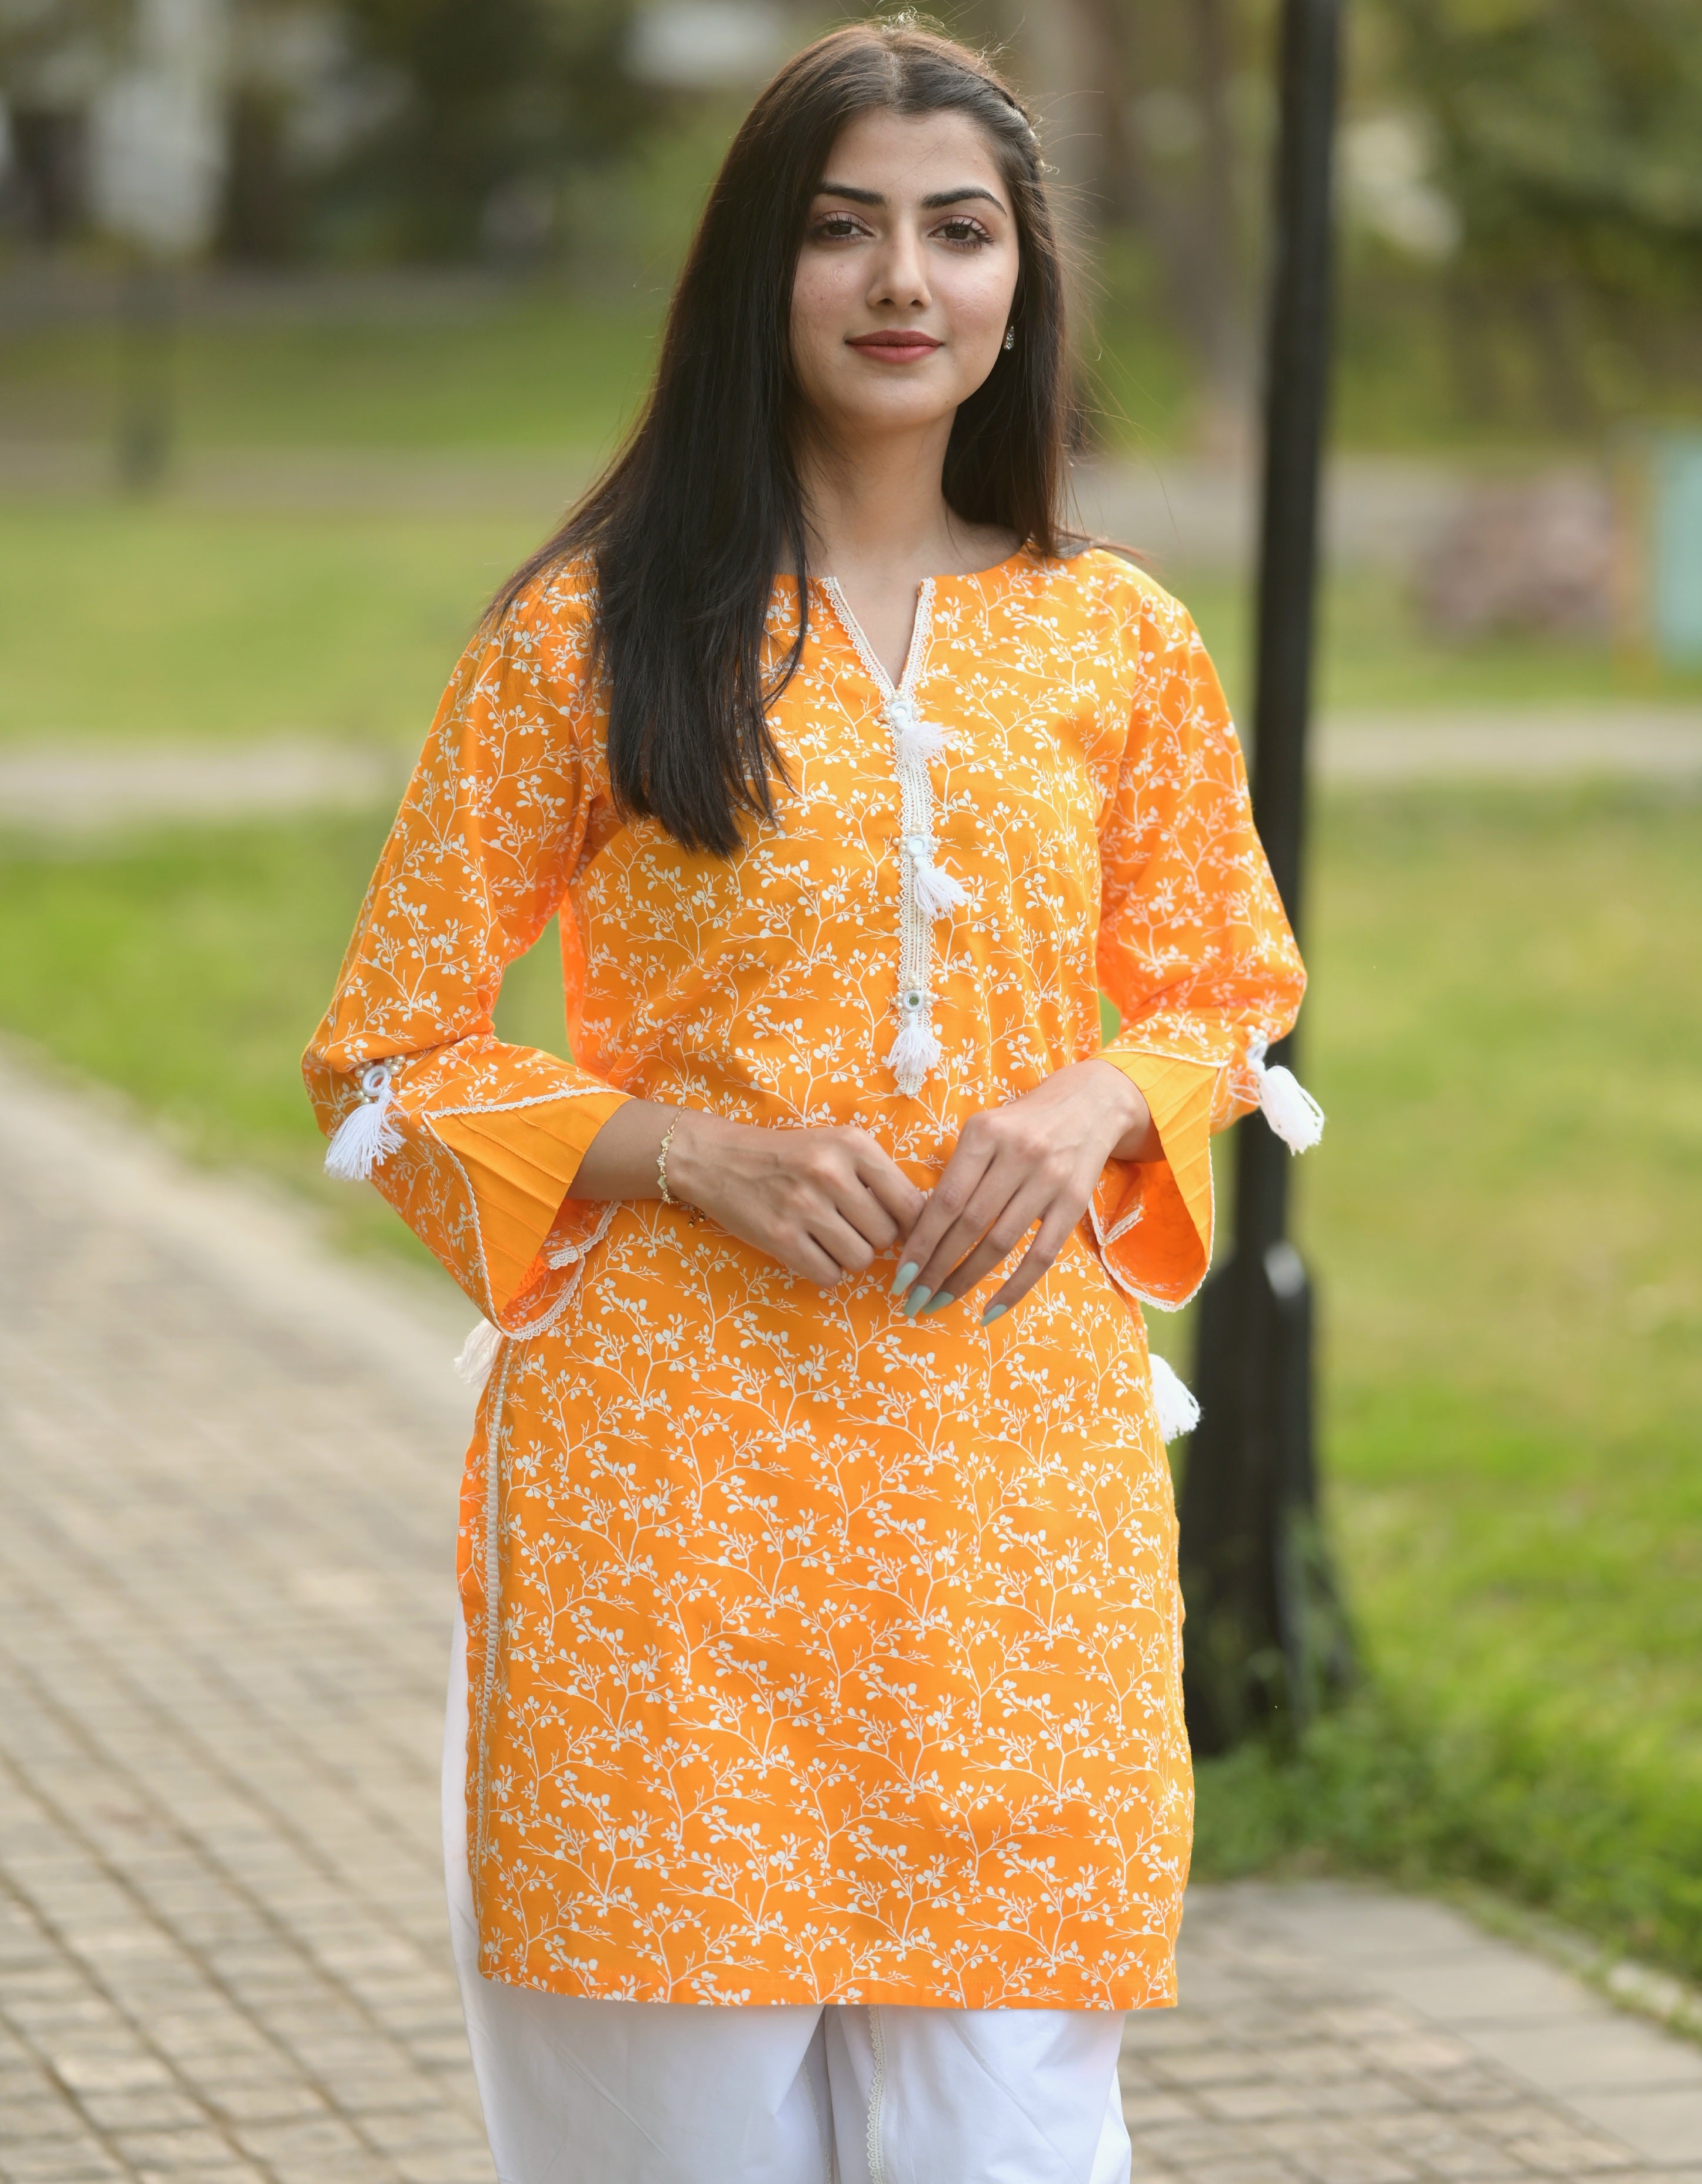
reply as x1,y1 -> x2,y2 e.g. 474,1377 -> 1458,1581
494,22 -> 1071,856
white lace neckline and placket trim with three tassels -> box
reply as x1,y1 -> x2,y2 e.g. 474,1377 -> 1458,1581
826,576 -> 970,1099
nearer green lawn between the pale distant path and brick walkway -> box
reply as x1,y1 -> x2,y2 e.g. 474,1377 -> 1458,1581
0,793 -> 1702,1972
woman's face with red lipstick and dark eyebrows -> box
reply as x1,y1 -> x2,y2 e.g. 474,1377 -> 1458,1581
791,111 -> 1018,456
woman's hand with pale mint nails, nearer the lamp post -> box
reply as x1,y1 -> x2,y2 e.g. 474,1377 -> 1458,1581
894,1059 -> 1163,1326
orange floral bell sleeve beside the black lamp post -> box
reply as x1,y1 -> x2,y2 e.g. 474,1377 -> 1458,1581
1090,588 -> 1322,1311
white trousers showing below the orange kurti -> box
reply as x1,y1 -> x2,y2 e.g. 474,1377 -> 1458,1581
444,1623 -> 1130,2184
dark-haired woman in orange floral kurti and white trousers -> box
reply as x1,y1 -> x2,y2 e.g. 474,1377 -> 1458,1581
306,24 -> 1302,2184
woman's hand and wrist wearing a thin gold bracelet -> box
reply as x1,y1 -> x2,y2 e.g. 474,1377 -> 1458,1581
572,1099 -> 927,1289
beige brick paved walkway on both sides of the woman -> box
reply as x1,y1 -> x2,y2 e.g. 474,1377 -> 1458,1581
0,1062 -> 1702,2184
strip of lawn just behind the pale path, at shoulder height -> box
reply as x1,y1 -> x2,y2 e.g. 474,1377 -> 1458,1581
0,502 -> 1702,751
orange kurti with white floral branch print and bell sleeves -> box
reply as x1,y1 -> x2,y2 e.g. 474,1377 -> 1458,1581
306,551 -> 1302,2009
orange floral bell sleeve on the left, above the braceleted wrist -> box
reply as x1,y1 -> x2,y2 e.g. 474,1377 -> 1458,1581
301,576 -> 627,1335
